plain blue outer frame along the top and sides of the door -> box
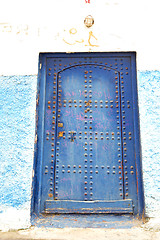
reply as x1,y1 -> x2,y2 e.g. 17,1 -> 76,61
31,52 -> 144,216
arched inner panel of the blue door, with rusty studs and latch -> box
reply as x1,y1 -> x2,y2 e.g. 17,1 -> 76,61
55,65 -> 123,201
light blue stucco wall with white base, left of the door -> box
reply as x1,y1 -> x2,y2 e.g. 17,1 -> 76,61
0,76 -> 36,229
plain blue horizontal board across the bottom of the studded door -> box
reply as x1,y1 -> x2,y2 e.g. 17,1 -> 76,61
44,199 -> 133,213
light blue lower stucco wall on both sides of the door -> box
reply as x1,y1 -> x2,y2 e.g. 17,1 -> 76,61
0,71 -> 160,230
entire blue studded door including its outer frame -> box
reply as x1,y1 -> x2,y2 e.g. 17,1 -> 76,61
32,52 -> 144,218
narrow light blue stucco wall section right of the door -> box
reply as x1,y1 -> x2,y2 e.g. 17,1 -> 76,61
138,71 -> 160,217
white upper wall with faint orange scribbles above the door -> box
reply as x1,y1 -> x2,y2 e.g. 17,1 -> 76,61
0,0 -> 160,75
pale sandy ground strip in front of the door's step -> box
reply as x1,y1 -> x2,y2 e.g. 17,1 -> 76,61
0,218 -> 160,240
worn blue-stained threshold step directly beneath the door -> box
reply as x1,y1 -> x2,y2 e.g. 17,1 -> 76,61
31,214 -> 144,229
